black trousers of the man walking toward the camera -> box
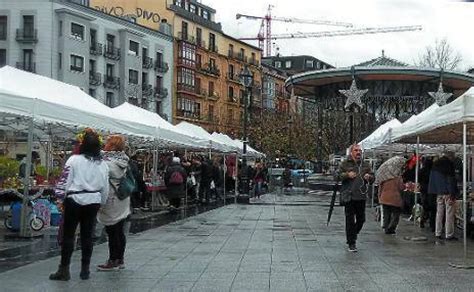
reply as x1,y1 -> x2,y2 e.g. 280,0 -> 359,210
344,200 -> 365,245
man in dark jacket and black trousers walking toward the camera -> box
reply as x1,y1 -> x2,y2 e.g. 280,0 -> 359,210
339,144 -> 373,252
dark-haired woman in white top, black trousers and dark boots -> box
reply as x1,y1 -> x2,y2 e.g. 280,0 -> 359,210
49,128 -> 109,281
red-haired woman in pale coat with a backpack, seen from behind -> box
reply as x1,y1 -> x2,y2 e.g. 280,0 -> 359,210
97,135 -> 130,271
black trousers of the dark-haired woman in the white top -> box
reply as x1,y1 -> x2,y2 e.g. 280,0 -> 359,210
61,198 -> 100,266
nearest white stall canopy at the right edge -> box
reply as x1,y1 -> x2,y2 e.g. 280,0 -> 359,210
398,87 -> 474,144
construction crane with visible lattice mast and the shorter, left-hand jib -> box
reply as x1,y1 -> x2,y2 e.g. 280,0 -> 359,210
235,5 -> 352,56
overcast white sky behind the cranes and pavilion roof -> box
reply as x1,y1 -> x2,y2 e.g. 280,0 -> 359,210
202,0 -> 474,69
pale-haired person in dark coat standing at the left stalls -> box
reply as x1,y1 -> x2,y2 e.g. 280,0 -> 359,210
165,157 -> 187,208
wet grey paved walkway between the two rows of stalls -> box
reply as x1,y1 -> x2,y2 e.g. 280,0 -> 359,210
0,191 -> 474,291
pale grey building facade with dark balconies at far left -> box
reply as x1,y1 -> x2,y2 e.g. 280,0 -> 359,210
0,0 -> 173,119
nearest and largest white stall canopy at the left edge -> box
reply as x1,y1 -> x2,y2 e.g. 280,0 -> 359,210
0,66 -> 154,138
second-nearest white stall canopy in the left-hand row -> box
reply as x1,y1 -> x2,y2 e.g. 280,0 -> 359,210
112,102 -> 207,149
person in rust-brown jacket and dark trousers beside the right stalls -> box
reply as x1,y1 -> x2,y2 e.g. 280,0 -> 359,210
375,156 -> 405,234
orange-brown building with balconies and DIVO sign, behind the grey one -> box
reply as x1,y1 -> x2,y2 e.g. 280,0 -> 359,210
88,0 -> 262,137
